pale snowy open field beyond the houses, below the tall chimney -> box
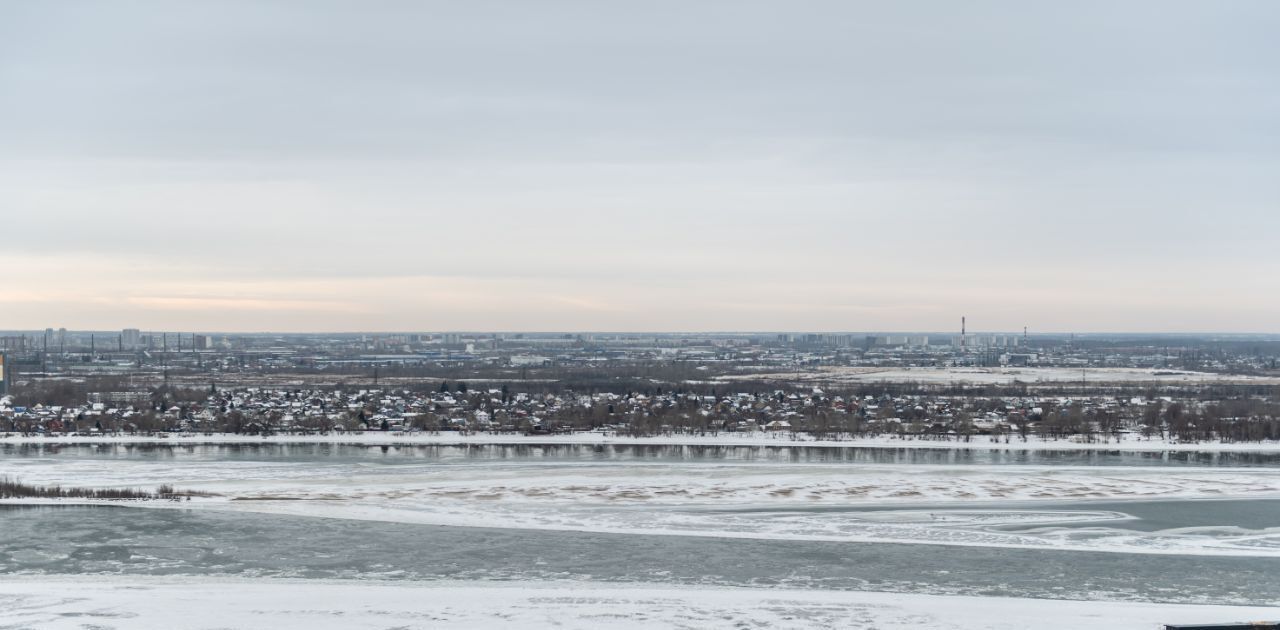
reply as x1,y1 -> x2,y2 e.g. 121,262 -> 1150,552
716,366 -> 1280,385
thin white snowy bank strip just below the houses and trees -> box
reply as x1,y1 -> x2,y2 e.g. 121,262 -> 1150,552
0,432 -> 1280,453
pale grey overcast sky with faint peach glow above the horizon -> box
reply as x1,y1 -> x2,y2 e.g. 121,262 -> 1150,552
0,0 -> 1280,332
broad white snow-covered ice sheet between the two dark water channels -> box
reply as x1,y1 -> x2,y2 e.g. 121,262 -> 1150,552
0,457 -> 1280,556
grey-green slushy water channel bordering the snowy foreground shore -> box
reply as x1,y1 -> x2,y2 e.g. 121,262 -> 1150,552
0,501 -> 1280,604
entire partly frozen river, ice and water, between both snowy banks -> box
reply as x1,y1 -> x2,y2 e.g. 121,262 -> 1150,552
0,444 -> 1280,624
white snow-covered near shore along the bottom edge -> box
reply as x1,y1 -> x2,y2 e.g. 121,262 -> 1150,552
0,578 -> 1280,630
